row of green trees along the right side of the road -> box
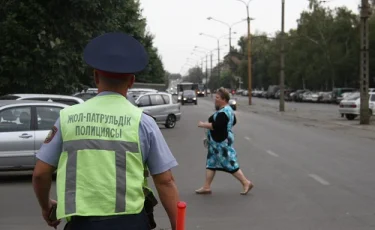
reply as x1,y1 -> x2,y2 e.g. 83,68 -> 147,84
195,0 -> 375,90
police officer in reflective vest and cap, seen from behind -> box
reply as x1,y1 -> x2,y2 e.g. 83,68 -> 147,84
33,33 -> 179,230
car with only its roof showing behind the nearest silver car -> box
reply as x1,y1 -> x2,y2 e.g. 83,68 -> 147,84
0,93 -> 85,105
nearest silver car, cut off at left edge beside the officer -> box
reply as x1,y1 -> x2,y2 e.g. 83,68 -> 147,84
0,100 -> 68,171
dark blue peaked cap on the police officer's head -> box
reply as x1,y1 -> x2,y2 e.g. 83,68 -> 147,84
83,33 -> 148,74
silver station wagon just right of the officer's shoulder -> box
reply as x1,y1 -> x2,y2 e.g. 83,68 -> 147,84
135,92 -> 181,128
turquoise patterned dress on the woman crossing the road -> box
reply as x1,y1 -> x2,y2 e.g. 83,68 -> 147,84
206,105 -> 239,173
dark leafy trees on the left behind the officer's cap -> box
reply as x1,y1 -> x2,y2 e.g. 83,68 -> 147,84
0,0 -> 164,94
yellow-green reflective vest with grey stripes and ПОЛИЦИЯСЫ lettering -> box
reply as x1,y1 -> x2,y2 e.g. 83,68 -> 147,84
56,95 -> 145,219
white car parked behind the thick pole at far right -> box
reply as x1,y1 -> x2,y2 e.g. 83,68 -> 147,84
339,92 -> 375,120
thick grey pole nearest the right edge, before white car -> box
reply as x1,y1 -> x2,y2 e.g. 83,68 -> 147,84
360,0 -> 370,125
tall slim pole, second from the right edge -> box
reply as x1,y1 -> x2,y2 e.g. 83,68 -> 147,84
279,0 -> 285,112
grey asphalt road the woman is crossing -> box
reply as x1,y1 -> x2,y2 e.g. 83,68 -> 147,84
0,96 -> 375,230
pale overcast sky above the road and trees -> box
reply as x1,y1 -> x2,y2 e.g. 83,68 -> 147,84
140,0 -> 360,75
